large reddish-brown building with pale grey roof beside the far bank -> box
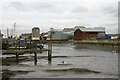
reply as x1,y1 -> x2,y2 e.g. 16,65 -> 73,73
74,27 -> 105,40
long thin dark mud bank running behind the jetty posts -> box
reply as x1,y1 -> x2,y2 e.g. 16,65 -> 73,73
2,53 -> 100,66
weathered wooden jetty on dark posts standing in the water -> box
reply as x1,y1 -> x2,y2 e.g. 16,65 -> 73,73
2,44 -> 52,65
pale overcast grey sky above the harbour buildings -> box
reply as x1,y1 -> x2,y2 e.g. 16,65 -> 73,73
0,0 -> 119,35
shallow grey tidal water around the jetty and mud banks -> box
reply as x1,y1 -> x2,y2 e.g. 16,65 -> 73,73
3,44 -> 118,78
